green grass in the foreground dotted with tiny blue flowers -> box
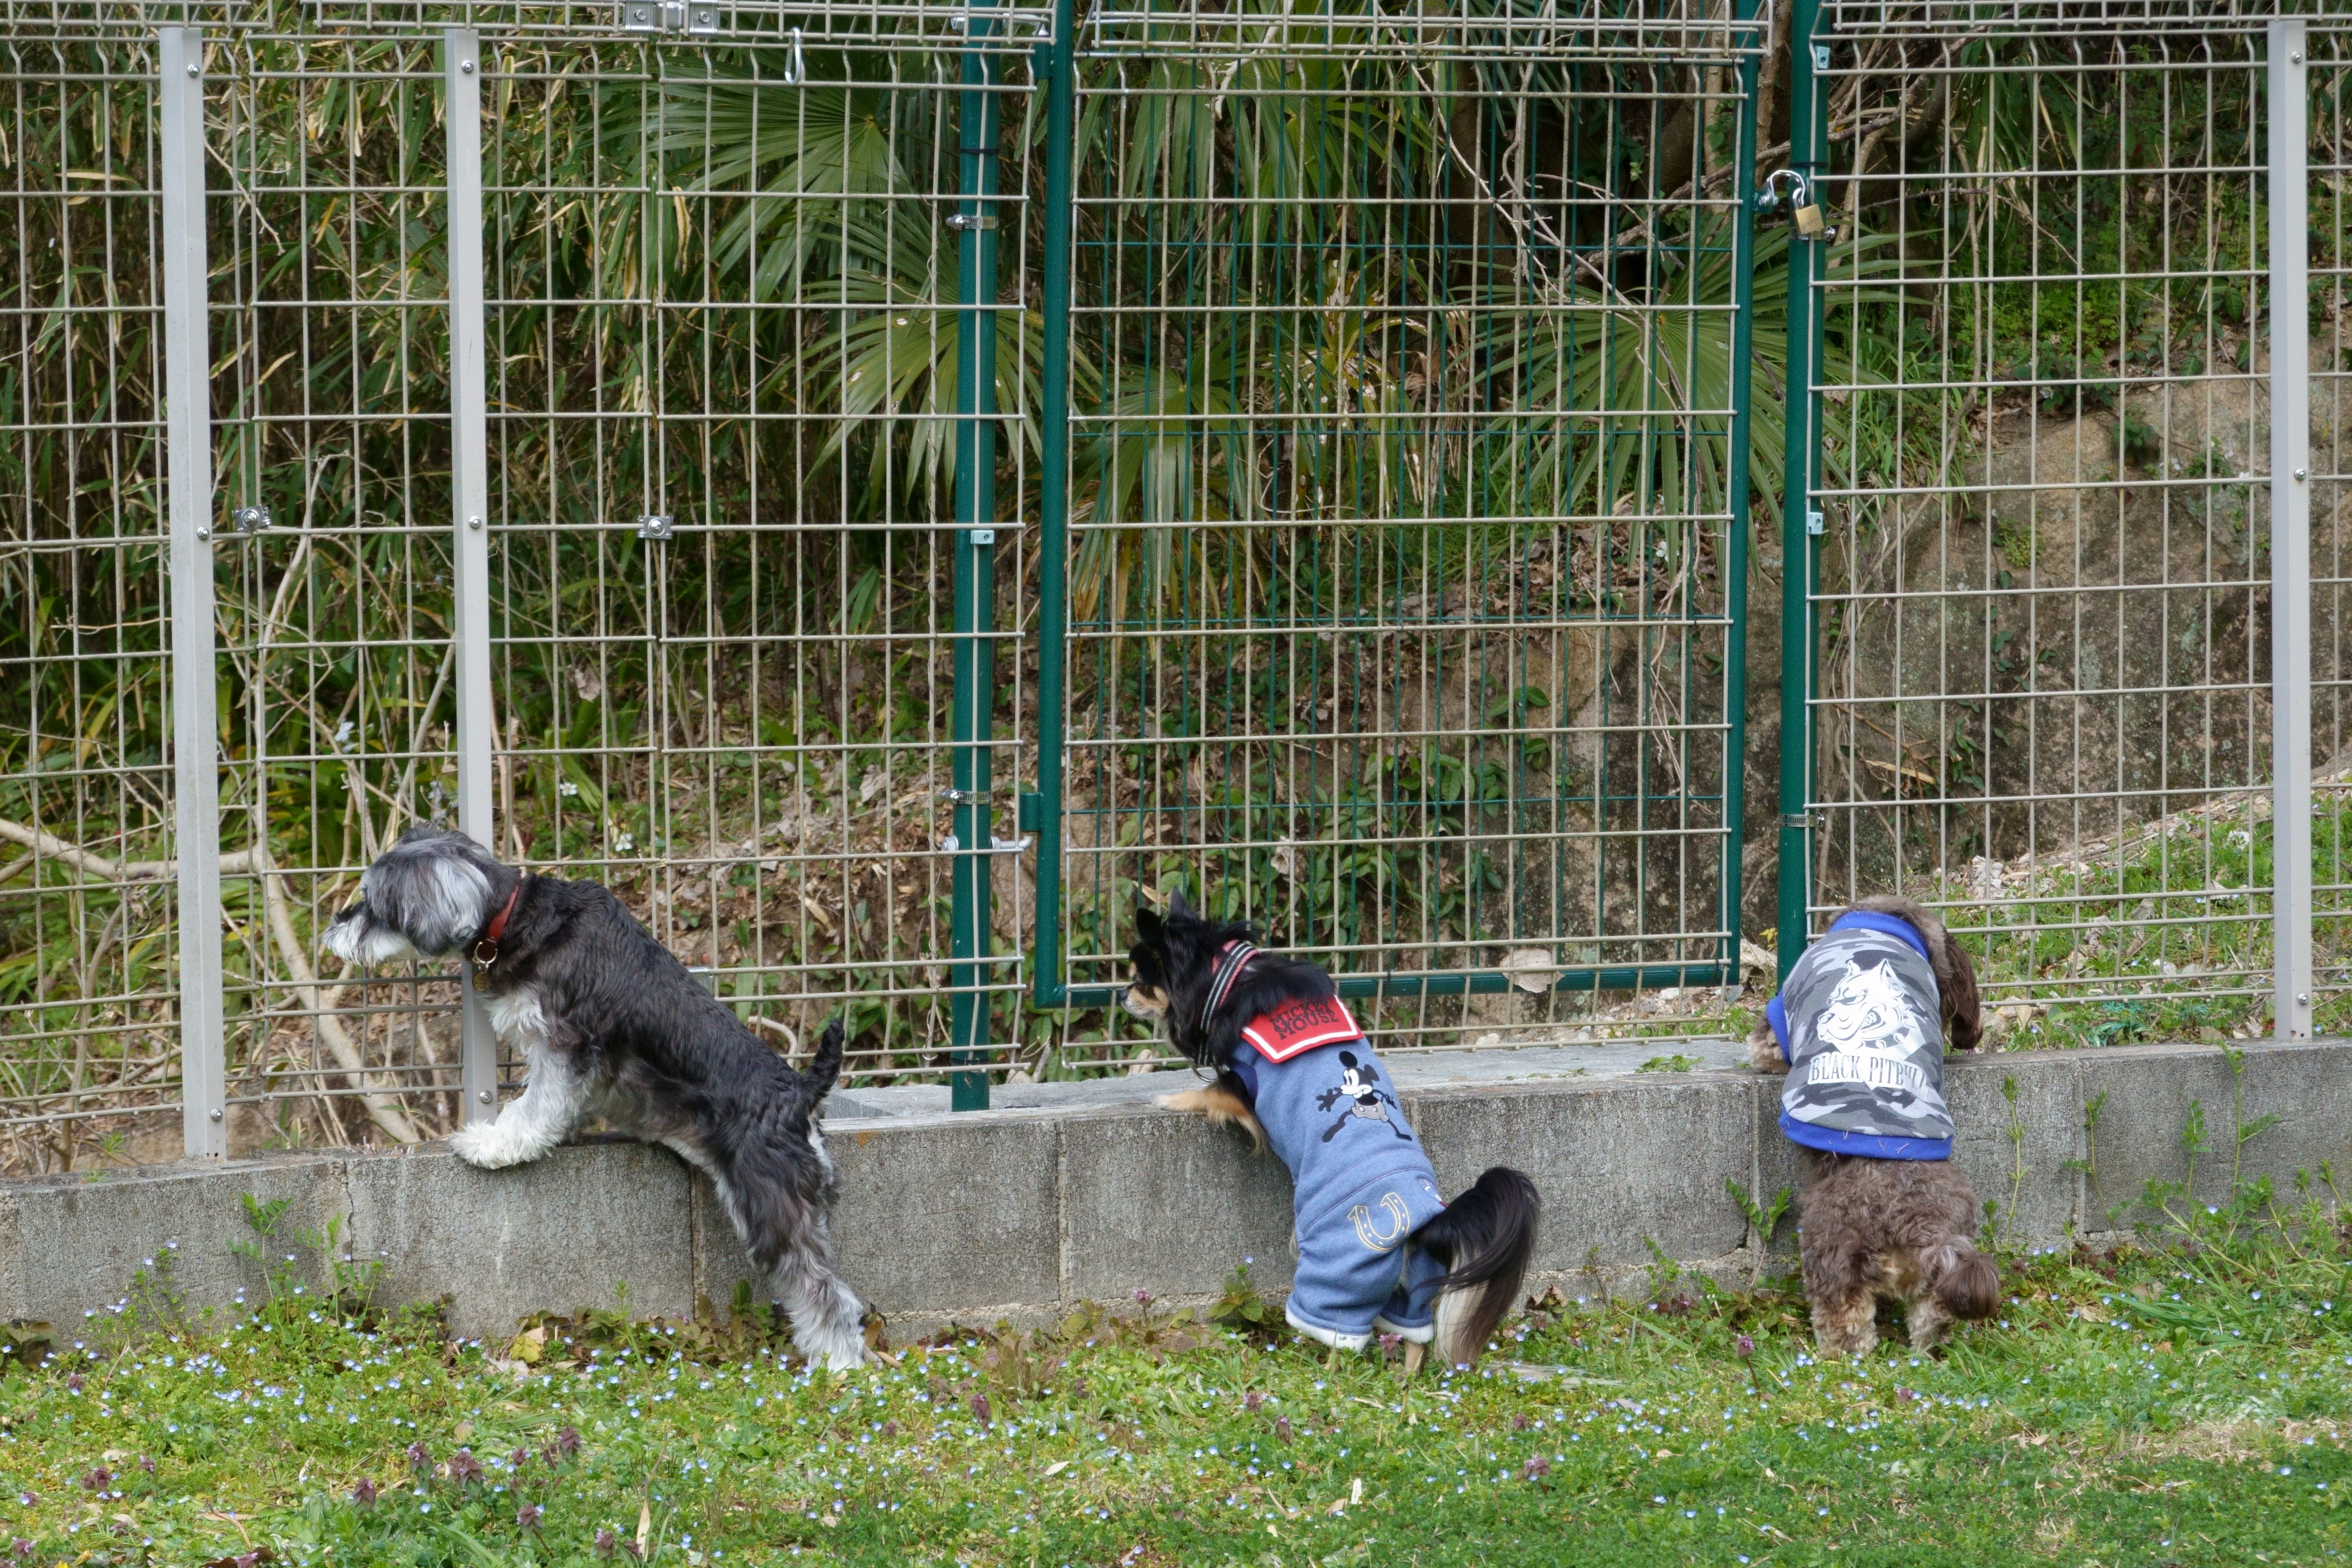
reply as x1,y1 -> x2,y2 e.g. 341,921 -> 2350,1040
0,1187 -> 2352,1568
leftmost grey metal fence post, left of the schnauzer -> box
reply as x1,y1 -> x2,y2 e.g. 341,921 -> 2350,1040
155,28 -> 228,1159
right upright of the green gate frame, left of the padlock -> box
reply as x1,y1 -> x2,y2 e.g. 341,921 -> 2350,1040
1722,0 -> 1769,985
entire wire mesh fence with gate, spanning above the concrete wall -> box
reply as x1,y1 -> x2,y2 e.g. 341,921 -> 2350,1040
0,0 -> 2352,1171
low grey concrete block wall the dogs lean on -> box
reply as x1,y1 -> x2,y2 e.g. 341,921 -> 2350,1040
0,1044 -> 2352,1340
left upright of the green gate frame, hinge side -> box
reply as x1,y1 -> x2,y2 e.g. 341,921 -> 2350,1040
1021,0 -> 1077,1006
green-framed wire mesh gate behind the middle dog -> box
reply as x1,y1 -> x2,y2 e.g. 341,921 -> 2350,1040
1033,2 -> 1764,1065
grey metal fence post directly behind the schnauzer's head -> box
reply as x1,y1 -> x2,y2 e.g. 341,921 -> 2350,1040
442,28 -> 499,1124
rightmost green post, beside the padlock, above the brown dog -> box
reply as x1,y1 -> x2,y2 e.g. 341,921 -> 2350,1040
1778,0 -> 1828,981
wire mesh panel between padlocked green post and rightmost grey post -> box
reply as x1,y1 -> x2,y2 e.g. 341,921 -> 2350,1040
1783,7 -> 2340,1039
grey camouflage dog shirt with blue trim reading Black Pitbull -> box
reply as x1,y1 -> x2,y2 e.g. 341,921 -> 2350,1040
1764,910 -> 1952,1159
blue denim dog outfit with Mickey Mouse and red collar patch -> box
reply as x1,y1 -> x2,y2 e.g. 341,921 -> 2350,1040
1209,945 -> 1444,1350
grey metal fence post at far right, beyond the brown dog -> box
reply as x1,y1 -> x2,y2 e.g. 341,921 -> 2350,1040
2267,17 -> 2312,1039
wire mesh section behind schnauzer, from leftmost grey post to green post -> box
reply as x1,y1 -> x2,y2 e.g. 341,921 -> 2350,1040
197,15 -> 1030,1138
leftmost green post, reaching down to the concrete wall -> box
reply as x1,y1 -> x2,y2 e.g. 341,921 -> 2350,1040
948,0 -> 997,1110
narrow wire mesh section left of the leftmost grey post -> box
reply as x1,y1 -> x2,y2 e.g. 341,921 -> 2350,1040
0,26 -> 179,1169
